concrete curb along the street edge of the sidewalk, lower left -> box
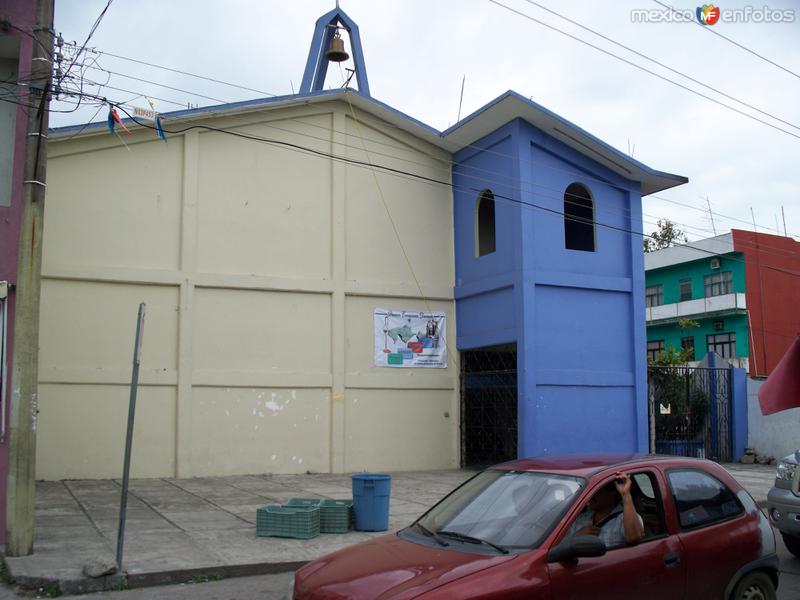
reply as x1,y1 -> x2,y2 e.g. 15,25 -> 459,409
3,557 -> 308,595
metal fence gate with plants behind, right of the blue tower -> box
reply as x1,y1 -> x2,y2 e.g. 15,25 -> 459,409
647,366 -> 733,461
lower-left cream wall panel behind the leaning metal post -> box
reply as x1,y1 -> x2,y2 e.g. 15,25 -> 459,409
36,384 -> 175,480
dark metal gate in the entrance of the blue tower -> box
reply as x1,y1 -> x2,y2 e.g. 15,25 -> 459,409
461,344 -> 517,467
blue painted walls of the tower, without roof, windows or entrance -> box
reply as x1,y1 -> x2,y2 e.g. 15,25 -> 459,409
453,118 -> 648,456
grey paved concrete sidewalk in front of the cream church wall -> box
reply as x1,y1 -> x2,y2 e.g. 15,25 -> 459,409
0,464 -> 775,594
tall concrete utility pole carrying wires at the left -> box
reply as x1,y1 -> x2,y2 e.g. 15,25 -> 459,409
6,0 -> 53,556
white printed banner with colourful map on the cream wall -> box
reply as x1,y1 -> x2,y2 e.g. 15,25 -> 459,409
374,308 -> 447,369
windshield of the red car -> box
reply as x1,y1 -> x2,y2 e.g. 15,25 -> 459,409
417,469 -> 584,548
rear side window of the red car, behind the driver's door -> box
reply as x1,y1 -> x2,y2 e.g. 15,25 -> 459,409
667,469 -> 744,529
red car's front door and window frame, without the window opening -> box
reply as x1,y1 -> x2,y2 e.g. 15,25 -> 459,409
548,469 -> 685,600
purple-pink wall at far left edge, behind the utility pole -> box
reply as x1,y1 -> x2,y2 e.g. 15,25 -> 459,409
0,0 -> 35,543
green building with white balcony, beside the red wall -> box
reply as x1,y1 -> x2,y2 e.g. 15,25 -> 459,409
645,233 -> 750,368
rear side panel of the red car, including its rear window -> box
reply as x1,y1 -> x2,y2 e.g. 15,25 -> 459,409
667,468 -> 761,600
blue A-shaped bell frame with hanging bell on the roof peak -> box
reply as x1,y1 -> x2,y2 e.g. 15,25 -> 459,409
300,1 -> 369,96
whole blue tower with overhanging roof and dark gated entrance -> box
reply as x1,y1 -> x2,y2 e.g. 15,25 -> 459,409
450,92 -> 687,464
